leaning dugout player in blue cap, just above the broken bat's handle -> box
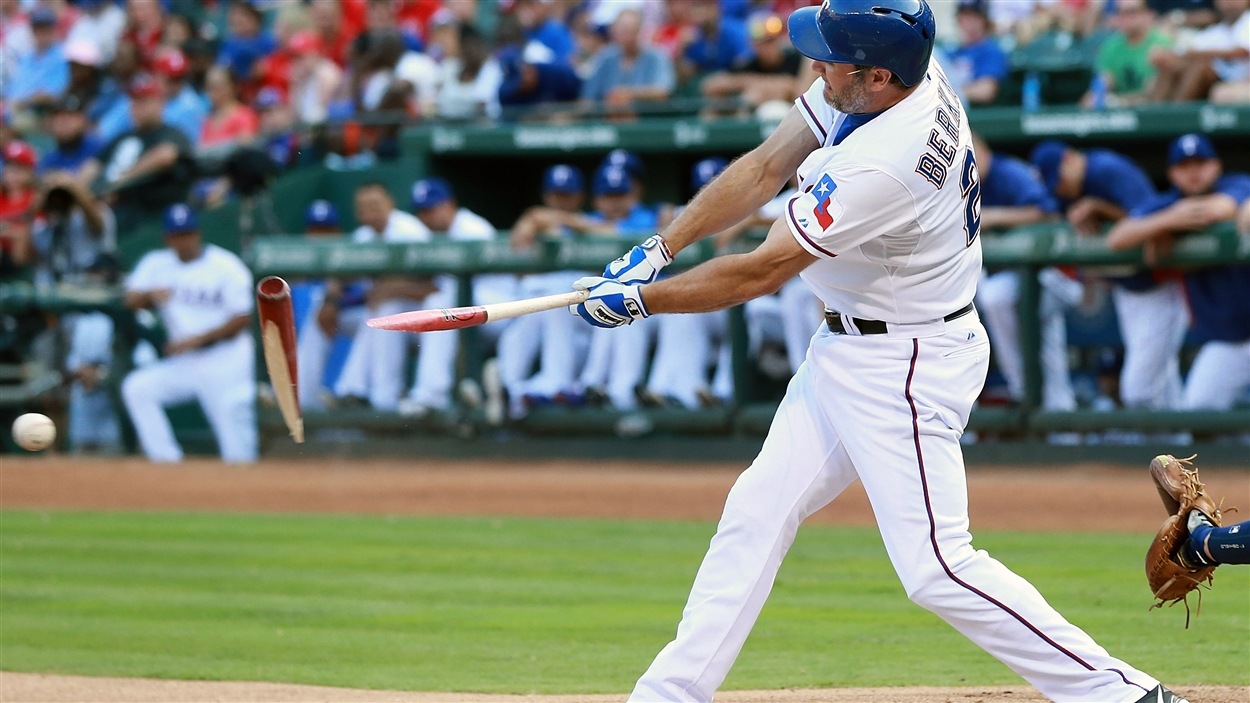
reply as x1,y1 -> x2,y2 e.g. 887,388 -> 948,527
495,164 -> 588,424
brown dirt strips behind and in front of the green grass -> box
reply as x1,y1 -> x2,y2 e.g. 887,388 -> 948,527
0,457 -> 1250,703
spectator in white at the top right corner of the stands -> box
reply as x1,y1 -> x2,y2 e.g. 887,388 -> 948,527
1151,0 -> 1250,103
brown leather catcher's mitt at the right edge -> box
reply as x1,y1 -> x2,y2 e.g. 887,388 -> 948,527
1146,454 -> 1223,627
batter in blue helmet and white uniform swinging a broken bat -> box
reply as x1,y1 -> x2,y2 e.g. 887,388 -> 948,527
570,0 -> 1183,703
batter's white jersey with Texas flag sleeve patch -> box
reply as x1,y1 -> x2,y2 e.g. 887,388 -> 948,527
785,61 -> 981,324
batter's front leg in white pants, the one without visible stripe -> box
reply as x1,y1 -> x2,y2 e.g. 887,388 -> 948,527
630,368 -> 855,702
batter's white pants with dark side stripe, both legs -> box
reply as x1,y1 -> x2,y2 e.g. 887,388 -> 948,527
630,314 -> 1158,703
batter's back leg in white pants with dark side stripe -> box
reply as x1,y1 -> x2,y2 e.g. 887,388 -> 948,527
813,316 -> 1159,703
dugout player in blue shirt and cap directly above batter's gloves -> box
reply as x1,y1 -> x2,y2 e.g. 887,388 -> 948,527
564,165 -> 656,410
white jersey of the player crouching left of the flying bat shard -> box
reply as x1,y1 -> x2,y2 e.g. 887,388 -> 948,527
126,244 -> 255,341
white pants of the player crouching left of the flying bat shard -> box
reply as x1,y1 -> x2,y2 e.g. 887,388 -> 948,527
121,334 -> 259,463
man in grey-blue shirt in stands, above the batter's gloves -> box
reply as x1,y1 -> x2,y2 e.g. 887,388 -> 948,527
581,10 -> 676,109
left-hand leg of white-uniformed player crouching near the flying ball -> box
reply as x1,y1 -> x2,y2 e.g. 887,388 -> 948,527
121,357 -> 196,464
